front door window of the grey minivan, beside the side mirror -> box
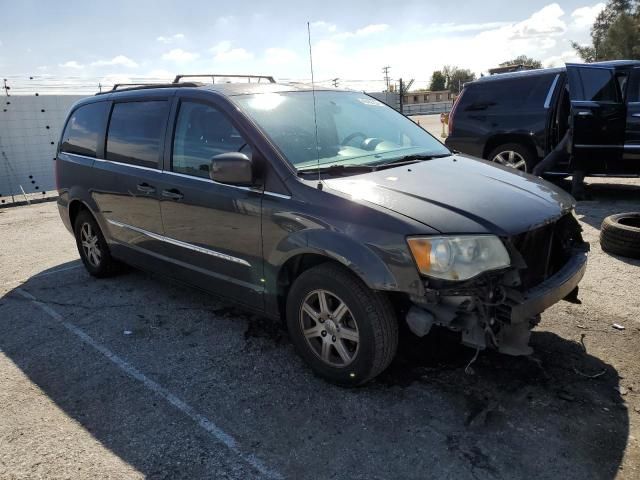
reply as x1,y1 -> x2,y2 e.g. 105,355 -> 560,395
171,102 -> 251,178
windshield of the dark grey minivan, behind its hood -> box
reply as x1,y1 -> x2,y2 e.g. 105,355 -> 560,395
234,91 -> 450,171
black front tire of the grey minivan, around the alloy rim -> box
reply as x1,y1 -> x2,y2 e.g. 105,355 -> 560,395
287,263 -> 398,386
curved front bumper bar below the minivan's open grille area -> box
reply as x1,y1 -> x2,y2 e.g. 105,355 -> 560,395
511,250 -> 588,323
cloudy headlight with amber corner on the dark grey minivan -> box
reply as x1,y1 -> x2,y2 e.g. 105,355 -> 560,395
407,235 -> 511,280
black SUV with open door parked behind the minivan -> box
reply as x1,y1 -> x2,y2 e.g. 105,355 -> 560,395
445,60 -> 640,176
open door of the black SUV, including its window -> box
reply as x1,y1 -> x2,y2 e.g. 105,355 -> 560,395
567,64 -> 626,174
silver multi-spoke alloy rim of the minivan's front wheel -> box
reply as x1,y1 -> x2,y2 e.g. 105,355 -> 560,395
300,290 -> 360,367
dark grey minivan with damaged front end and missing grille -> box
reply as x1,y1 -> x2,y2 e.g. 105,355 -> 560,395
56,75 -> 587,385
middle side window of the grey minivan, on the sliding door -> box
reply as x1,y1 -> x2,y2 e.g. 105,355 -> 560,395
107,100 -> 169,167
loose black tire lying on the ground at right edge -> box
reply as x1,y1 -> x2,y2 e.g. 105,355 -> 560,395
600,212 -> 640,258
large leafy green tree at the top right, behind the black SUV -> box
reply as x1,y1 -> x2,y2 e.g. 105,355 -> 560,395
572,0 -> 640,62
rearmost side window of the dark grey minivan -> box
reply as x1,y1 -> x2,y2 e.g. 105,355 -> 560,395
60,102 -> 107,158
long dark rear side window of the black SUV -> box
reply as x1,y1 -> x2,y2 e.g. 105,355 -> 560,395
458,74 -> 555,112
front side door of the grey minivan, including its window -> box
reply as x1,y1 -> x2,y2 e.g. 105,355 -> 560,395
158,93 -> 264,308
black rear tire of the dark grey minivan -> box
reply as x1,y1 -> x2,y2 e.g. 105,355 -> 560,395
73,210 -> 121,278
